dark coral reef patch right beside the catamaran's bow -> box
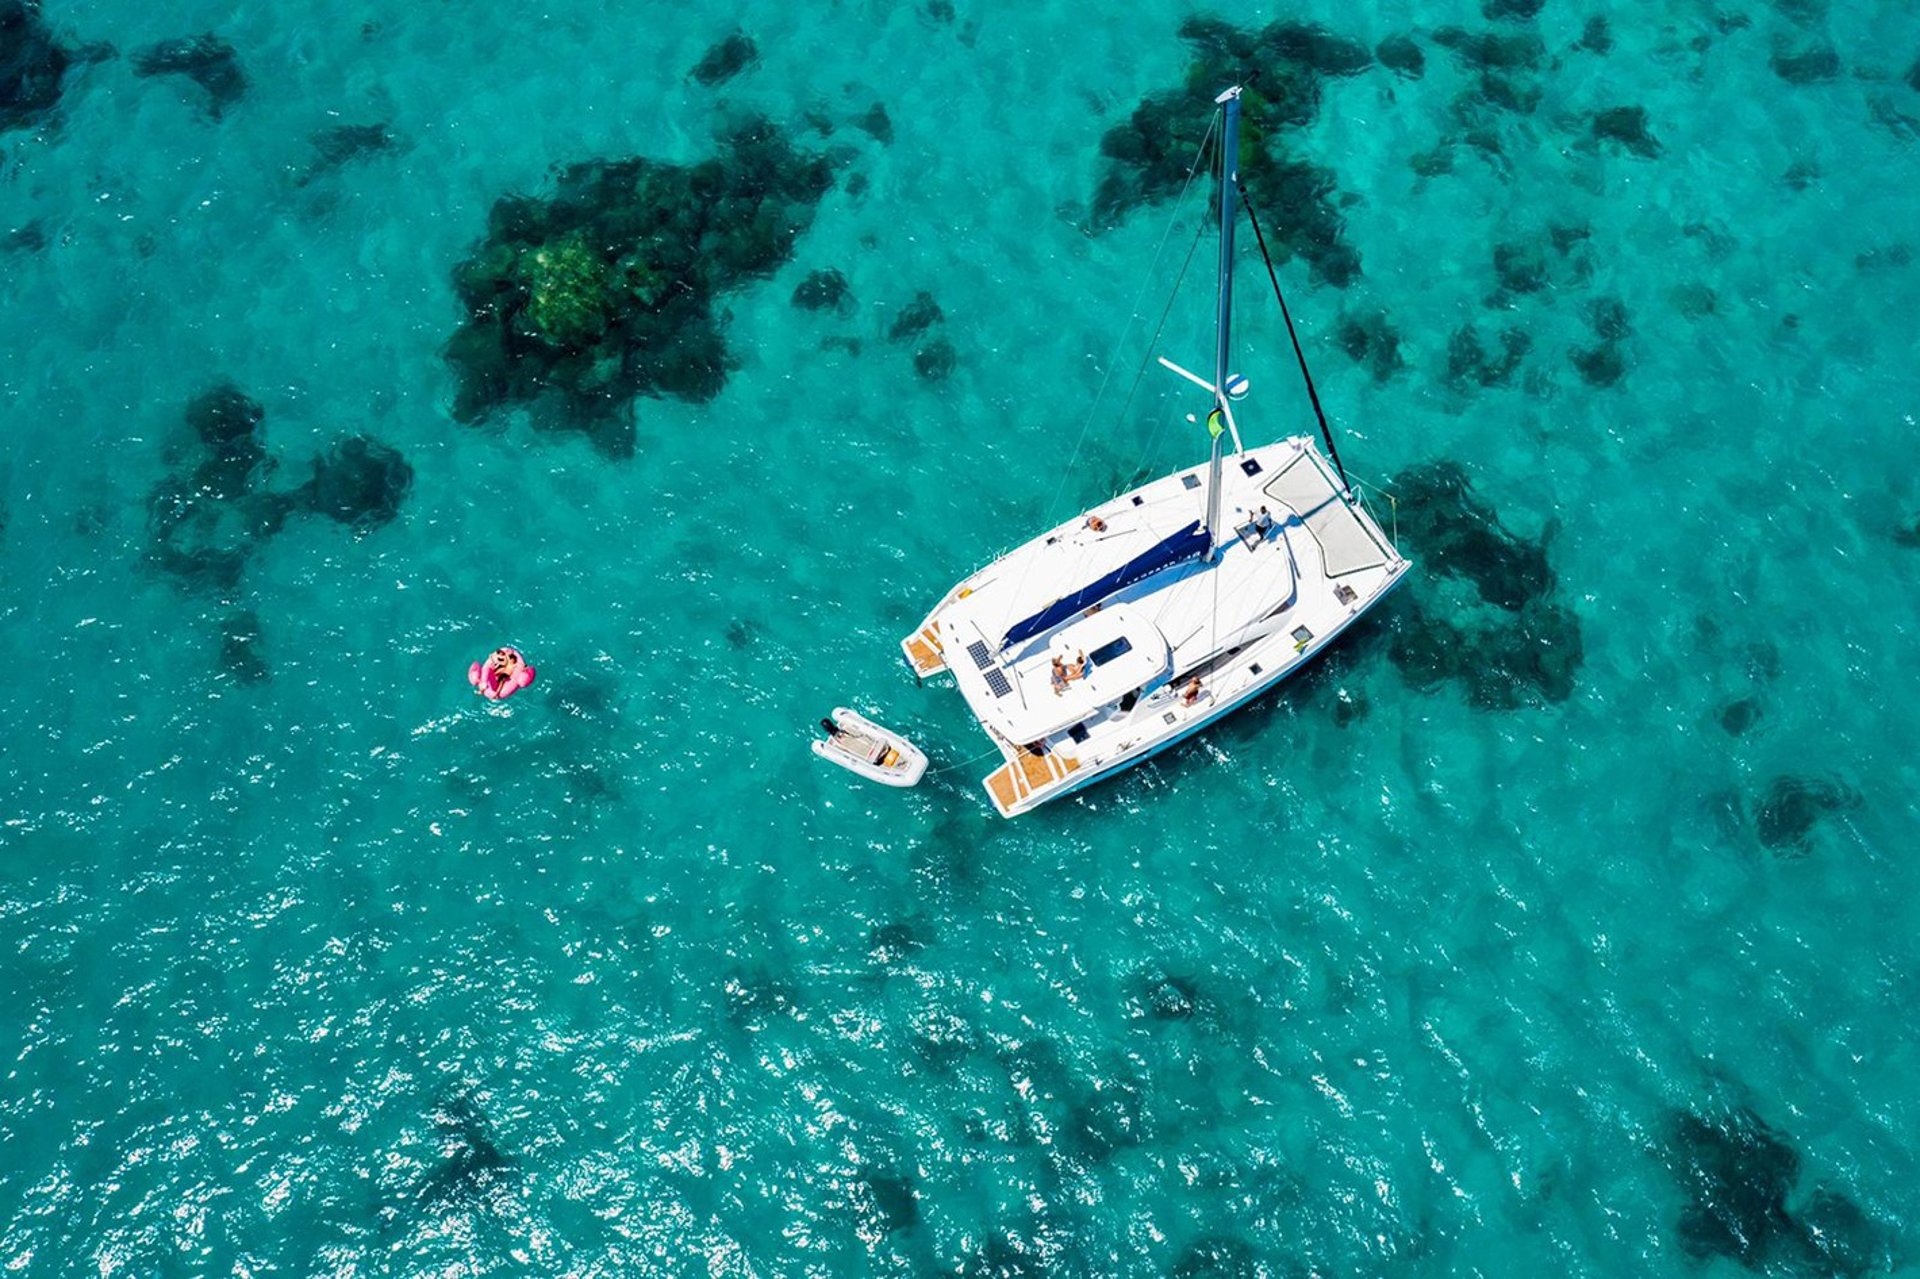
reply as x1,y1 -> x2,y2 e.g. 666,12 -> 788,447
1388,461 -> 1584,711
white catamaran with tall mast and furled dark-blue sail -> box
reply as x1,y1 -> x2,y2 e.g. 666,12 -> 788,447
900,86 -> 1409,816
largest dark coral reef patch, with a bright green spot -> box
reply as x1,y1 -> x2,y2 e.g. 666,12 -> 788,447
445,121 -> 833,453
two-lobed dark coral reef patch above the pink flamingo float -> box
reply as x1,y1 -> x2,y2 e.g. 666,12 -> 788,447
148,382 -> 413,591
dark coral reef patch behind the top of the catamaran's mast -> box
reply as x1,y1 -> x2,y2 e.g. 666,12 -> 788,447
1091,17 -> 1374,288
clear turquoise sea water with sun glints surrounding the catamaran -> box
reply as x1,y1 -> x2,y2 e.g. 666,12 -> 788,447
0,0 -> 1920,1275
